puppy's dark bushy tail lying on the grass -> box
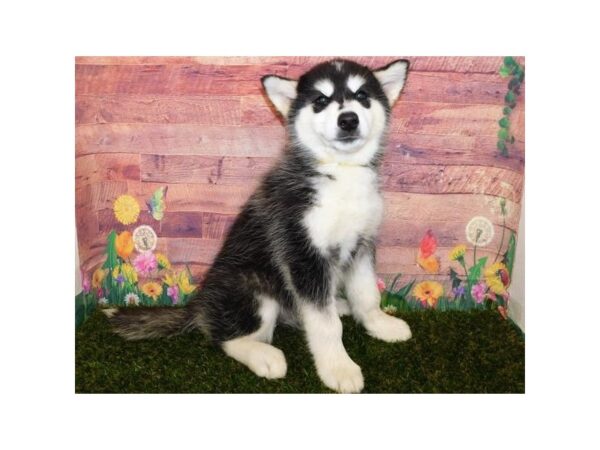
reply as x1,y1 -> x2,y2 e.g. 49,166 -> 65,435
103,306 -> 192,341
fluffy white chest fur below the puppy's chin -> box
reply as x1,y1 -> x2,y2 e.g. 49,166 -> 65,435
304,164 -> 383,262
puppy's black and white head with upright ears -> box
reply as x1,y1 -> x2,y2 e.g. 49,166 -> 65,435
262,60 -> 408,162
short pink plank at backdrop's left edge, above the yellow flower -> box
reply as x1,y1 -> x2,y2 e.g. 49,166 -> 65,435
75,153 -> 140,187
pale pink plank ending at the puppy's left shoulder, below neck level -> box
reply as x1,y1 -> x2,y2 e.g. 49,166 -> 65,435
141,155 -> 275,185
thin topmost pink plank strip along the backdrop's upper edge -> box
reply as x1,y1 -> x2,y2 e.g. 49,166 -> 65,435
75,56 -> 523,73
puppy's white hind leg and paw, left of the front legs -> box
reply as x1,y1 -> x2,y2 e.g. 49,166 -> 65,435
222,296 -> 287,378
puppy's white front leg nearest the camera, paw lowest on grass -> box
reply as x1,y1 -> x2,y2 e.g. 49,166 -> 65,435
300,301 -> 364,392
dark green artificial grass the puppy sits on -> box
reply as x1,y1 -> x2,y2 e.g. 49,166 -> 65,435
75,310 -> 525,393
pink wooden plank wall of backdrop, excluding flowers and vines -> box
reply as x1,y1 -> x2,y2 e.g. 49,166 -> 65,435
75,56 -> 525,288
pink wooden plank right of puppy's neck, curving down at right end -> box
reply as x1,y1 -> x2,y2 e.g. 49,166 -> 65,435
381,161 -> 523,203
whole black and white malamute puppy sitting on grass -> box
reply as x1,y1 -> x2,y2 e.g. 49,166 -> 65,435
107,60 -> 411,392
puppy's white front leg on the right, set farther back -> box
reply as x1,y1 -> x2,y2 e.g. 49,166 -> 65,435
345,255 -> 412,342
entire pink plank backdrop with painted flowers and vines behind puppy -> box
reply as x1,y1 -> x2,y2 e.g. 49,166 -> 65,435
76,57 -> 524,325
